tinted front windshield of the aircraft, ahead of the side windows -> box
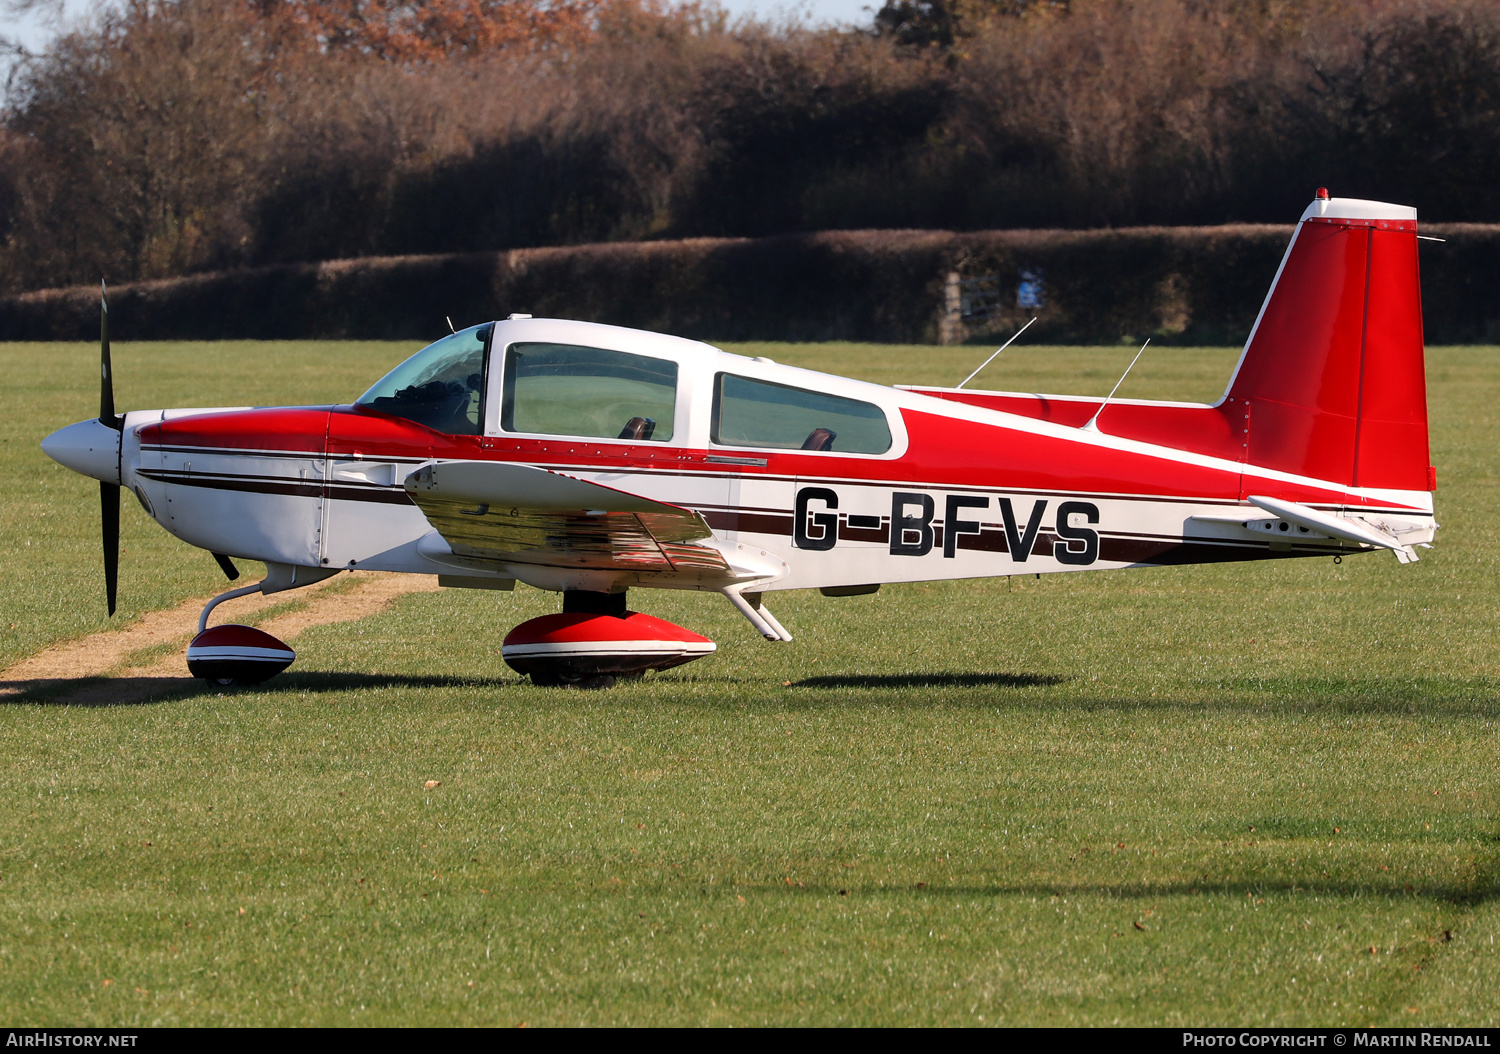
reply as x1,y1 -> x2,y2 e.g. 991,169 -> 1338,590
354,322 -> 495,435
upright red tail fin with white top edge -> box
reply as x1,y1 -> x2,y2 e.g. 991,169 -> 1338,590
1221,190 -> 1436,490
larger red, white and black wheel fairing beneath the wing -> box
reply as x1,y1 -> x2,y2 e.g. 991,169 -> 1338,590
501,589 -> 717,688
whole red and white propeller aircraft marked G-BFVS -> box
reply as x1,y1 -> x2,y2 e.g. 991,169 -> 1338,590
42,190 -> 1437,687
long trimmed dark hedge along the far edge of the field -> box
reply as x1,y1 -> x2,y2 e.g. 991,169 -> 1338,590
0,225 -> 1500,343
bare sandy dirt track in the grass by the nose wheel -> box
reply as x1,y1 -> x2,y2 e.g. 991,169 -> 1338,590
0,571 -> 438,706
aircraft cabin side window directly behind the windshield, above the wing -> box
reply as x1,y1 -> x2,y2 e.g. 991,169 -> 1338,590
500,343 -> 677,442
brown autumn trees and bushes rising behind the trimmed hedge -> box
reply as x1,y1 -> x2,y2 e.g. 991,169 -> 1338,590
0,0 -> 1500,292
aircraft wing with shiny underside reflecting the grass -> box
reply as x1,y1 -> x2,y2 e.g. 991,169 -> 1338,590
404,462 -> 729,573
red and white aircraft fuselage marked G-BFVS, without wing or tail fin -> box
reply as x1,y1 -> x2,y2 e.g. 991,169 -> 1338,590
65,319 -> 1434,589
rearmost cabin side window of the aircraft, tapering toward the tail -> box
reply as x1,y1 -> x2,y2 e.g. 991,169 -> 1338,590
711,373 -> 891,454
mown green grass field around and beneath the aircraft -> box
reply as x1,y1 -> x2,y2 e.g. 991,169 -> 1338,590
0,343 -> 1500,1026
